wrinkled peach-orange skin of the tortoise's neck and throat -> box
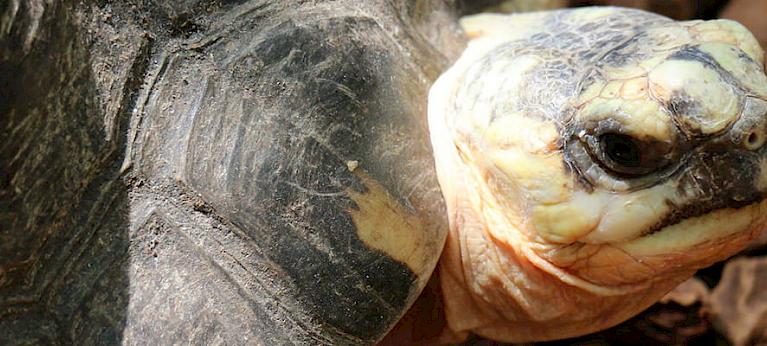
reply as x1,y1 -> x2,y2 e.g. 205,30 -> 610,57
429,87 -> 759,342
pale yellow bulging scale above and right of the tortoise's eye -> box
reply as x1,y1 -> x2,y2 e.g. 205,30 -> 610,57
649,60 -> 740,135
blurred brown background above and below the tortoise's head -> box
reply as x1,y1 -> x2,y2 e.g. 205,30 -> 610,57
461,0 -> 767,346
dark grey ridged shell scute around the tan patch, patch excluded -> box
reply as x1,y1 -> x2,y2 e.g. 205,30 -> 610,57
179,17 -> 426,343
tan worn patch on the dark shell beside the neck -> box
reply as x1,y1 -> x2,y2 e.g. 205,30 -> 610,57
346,168 -> 432,285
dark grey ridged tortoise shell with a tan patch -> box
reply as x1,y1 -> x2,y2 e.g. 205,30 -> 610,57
0,1 -> 463,345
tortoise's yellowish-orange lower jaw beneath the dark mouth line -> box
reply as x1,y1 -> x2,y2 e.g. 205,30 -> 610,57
520,200 -> 767,296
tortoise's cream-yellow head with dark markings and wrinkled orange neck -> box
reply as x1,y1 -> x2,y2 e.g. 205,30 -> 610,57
429,8 -> 767,342
